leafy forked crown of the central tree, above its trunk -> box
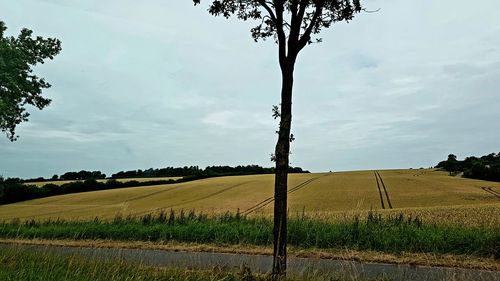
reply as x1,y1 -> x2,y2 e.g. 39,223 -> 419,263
193,0 -> 363,62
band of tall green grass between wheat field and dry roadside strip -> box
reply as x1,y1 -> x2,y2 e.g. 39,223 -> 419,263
0,211 -> 500,259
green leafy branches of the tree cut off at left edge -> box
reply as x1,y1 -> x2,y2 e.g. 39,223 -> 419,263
0,21 -> 61,141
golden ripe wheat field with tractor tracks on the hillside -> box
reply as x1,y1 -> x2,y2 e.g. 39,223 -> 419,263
0,170 -> 500,225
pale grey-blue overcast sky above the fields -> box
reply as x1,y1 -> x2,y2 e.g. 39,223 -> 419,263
0,0 -> 500,177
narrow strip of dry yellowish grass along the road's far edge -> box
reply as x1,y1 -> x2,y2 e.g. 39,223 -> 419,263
0,236 -> 500,271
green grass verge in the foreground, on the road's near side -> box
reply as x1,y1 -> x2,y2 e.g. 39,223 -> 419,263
0,248 -> 390,281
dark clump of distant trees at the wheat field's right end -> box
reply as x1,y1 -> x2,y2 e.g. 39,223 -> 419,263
436,153 -> 500,182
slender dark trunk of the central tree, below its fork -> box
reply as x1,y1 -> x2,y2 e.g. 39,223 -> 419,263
272,63 -> 294,280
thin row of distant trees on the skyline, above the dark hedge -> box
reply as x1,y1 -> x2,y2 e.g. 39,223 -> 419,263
22,165 -> 309,183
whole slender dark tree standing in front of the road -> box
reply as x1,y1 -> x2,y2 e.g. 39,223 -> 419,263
193,0 -> 362,277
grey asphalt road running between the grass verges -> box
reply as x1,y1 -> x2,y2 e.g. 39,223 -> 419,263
0,244 -> 500,281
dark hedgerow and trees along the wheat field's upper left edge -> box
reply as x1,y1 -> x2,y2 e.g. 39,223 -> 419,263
0,165 -> 308,205
